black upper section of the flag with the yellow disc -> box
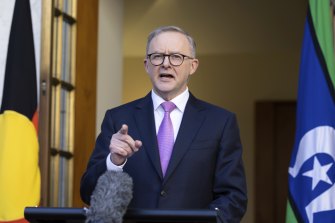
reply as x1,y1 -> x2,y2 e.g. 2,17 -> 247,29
0,0 -> 37,120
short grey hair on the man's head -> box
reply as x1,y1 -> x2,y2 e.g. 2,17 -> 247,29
146,26 -> 196,58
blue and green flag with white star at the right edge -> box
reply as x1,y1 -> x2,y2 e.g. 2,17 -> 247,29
286,0 -> 335,223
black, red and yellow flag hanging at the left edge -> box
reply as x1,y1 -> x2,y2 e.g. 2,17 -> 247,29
0,0 -> 40,223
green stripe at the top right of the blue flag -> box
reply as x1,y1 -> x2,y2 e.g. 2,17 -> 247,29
309,0 -> 335,88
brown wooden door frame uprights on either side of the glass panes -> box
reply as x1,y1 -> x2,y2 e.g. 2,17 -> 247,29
38,0 -> 99,207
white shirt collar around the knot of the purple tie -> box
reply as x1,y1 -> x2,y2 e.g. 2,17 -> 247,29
151,88 -> 190,112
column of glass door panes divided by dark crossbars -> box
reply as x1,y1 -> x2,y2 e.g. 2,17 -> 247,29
50,0 -> 76,207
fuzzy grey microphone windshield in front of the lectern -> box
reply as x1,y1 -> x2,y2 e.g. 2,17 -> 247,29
86,171 -> 133,223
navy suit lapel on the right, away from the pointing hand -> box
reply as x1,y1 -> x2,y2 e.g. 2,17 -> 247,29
163,94 -> 205,183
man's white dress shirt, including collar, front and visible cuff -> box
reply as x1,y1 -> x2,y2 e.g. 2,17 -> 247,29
106,88 -> 190,171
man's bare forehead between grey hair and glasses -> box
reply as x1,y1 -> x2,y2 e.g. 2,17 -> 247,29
148,32 -> 191,53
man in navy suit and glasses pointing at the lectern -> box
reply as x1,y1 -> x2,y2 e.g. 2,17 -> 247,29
81,26 -> 247,223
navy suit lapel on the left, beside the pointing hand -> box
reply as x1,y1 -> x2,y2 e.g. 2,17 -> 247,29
135,93 -> 163,178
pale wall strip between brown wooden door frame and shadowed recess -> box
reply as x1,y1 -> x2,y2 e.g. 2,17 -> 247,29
96,0 -> 123,134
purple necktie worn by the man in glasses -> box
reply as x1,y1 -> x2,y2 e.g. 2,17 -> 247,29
157,101 -> 176,176
